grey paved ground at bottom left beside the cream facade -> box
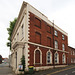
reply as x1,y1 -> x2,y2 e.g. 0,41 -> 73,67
0,63 -> 15,75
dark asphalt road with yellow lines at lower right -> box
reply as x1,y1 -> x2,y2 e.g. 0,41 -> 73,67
47,66 -> 75,75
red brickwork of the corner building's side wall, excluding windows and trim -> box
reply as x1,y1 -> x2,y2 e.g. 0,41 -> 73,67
29,13 -> 68,66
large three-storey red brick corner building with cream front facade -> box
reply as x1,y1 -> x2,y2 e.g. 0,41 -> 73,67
11,2 -> 68,73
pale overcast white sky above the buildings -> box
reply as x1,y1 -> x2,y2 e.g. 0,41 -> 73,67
0,0 -> 75,58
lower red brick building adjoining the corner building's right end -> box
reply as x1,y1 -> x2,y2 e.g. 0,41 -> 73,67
68,46 -> 75,64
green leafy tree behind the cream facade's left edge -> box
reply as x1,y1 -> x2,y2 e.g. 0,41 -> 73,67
7,18 -> 17,50
